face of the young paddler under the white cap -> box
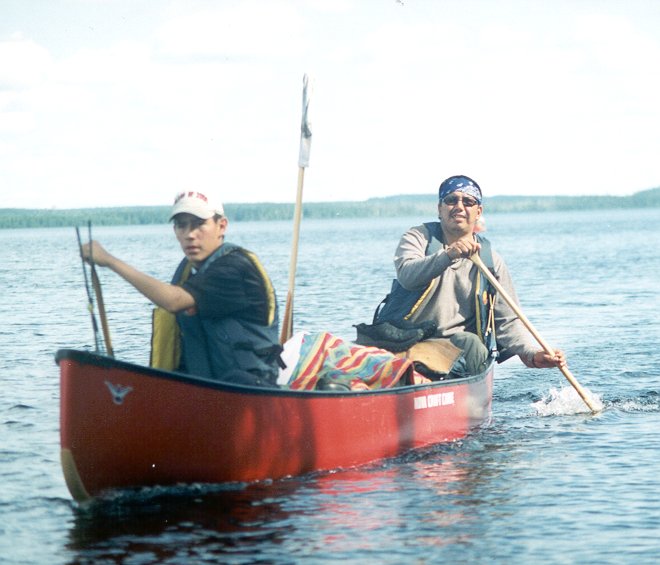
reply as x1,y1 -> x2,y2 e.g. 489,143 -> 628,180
174,214 -> 227,266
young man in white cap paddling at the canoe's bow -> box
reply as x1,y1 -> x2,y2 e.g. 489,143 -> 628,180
83,191 -> 281,386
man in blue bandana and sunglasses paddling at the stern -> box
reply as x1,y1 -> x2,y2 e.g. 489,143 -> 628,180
394,175 -> 566,374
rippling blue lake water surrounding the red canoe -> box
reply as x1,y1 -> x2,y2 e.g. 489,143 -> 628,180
0,210 -> 660,564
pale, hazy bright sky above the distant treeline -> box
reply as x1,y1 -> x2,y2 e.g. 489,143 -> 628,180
0,0 -> 660,209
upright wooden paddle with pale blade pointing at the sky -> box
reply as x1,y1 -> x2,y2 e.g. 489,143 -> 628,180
280,75 -> 312,343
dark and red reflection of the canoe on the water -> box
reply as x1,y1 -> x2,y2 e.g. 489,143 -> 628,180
67,430 -> 524,562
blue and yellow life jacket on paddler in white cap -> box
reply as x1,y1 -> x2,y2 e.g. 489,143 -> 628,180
152,243 -> 282,383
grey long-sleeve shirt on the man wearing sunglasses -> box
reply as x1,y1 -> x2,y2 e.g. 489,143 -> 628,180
394,225 -> 538,367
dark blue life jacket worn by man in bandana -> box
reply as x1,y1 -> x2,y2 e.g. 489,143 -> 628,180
374,222 -> 497,355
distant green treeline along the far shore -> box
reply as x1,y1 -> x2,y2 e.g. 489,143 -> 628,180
0,187 -> 660,229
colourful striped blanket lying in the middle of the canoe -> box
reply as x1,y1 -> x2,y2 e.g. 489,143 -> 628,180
288,332 -> 416,390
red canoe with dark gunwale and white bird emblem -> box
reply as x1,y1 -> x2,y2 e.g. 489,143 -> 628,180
56,349 -> 494,501
